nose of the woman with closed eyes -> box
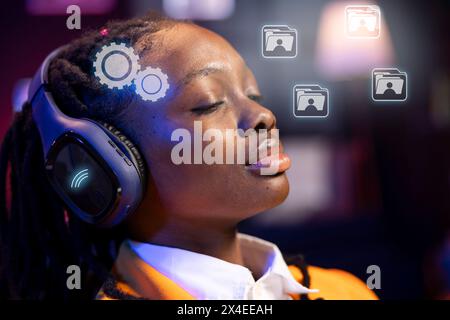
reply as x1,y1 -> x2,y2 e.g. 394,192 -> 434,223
238,101 -> 276,131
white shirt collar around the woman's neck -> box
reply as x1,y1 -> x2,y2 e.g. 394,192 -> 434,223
127,234 -> 317,300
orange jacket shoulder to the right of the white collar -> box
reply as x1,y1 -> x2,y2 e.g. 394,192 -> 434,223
289,265 -> 378,300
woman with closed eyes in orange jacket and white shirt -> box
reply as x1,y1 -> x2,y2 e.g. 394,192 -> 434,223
0,14 -> 376,299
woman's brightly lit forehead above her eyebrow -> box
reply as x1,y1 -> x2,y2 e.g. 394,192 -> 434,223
136,23 -> 245,83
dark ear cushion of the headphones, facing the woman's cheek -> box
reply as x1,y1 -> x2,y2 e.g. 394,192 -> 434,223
100,122 -> 146,185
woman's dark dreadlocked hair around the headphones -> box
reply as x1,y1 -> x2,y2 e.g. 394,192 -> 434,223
0,13 -> 183,300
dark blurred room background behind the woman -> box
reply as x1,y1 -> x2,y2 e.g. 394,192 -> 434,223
0,0 -> 450,299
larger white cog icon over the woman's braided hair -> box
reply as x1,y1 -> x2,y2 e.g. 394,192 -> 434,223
94,43 -> 140,89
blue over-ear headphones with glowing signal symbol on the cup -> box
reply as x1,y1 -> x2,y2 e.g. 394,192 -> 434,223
28,49 -> 146,227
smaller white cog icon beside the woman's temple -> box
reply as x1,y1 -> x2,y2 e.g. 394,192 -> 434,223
135,67 -> 169,102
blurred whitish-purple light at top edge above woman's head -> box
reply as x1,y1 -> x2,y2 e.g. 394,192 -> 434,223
163,0 -> 235,20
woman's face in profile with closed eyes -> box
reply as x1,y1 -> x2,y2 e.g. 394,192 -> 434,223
125,24 -> 289,221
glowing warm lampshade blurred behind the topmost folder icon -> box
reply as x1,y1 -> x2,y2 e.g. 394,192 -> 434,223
316,1 -> 394,81
